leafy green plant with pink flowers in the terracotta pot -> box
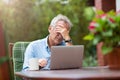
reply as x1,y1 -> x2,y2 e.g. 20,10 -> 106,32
84,10 -> 120,54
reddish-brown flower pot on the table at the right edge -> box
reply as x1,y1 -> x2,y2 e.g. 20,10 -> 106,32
105,47 -> 120,70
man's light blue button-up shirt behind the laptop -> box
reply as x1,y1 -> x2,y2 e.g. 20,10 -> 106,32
23,36 -> 65,71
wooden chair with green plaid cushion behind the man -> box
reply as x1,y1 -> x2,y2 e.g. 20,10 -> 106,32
9,41 -> 30,80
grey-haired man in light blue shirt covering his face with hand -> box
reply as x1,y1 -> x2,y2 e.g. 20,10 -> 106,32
23,14 -> 72,70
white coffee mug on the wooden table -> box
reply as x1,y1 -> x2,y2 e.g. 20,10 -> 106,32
29,58 -> 39,70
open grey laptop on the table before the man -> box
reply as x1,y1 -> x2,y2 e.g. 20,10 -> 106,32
50,45 -> 84,70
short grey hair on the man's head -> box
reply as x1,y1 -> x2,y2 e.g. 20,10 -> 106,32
50,14 -> 73,28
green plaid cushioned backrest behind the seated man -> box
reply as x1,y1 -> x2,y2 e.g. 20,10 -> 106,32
13,42 -> 30,72
